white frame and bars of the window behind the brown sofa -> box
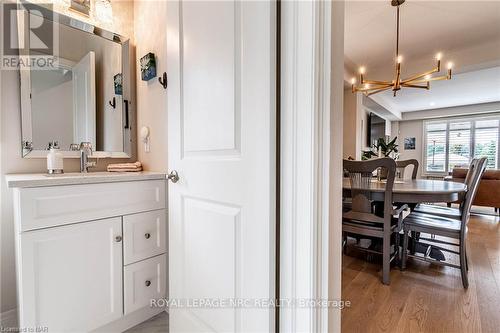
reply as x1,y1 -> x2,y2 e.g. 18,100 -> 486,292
422,113 -> 500,176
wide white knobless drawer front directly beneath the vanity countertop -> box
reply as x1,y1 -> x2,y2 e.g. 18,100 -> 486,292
16,180 -> 165,232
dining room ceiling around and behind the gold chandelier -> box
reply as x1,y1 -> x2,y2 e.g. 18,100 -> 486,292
344,0 -> 500,112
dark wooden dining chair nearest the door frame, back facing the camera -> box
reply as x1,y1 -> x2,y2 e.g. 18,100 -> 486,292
342,158 -> 404,284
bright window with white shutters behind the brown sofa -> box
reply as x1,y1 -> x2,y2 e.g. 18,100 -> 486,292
423,116 -> 500,174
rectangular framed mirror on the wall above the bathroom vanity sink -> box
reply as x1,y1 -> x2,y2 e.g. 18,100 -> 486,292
18,5 -> 135,158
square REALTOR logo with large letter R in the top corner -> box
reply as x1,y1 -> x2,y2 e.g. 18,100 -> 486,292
0,2 -> 59,70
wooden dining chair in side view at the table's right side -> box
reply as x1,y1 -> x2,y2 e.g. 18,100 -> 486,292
401,158 -> 487,288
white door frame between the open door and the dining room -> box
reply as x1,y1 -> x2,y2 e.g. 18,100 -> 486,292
279,0 -> 344,332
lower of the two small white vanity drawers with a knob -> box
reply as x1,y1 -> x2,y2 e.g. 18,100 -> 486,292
124,254 -> 167,314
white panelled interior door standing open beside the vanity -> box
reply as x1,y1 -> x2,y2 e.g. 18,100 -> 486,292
167,1 -> 276,332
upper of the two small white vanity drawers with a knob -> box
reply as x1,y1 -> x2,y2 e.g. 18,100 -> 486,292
123,209 -> 167,265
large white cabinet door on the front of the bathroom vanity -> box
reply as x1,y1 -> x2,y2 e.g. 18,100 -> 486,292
18,218 -> 123,332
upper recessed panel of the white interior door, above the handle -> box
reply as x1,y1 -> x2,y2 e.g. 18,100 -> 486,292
179,1 -> 241,156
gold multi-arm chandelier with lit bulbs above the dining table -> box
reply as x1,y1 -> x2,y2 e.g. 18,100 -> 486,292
351,0 -> 453,97
